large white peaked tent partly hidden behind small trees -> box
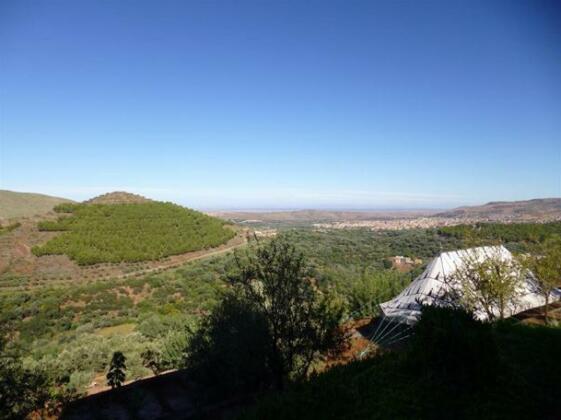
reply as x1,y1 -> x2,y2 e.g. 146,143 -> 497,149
380,246 -> 545,324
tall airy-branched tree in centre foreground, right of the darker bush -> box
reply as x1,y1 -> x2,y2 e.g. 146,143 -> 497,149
225,237 -> 343,389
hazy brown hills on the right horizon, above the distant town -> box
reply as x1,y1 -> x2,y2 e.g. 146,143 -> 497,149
436,198 -> 561,221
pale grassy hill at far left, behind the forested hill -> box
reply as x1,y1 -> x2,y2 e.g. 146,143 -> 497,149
0,190 -> 72,219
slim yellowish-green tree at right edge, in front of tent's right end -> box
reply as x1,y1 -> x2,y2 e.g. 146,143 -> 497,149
521,236 -> 561,324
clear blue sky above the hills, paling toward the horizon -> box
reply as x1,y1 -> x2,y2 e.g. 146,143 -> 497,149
0,0 -> 561,208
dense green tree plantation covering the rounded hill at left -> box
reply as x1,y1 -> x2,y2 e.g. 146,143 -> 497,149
33,202 -> 235,265
